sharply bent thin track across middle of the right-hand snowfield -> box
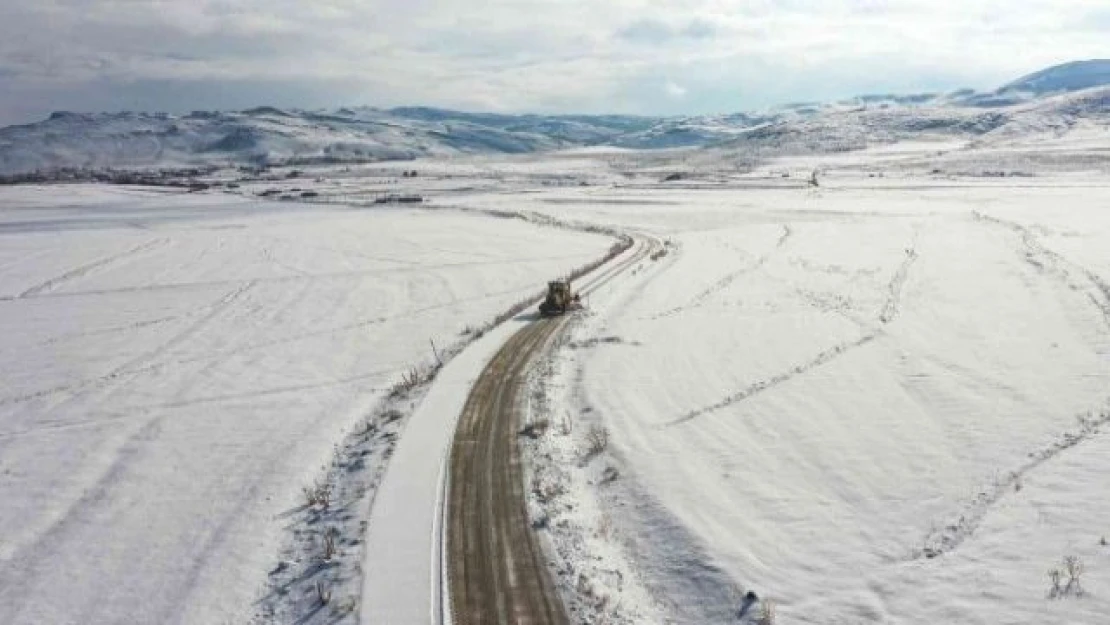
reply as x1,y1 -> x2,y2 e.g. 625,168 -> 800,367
662,234 -> 918,427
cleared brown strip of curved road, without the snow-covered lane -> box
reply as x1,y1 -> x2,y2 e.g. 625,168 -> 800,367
444,239 -> 658,625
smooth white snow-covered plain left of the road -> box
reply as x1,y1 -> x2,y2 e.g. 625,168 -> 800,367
0,185 -> 612,625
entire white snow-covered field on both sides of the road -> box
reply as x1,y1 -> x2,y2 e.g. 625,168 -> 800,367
0,128 -> 1110,625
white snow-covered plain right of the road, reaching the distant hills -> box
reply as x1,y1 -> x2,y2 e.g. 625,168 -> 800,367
483,154 -> 1110,625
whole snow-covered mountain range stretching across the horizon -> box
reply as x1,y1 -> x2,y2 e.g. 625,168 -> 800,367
0,60 -> 1110,174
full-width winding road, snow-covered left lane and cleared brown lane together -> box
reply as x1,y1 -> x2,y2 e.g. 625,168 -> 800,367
362,239 -> 658,624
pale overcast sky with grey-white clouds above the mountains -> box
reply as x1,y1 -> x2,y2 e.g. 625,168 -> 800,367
0,0 -> 1110,125
